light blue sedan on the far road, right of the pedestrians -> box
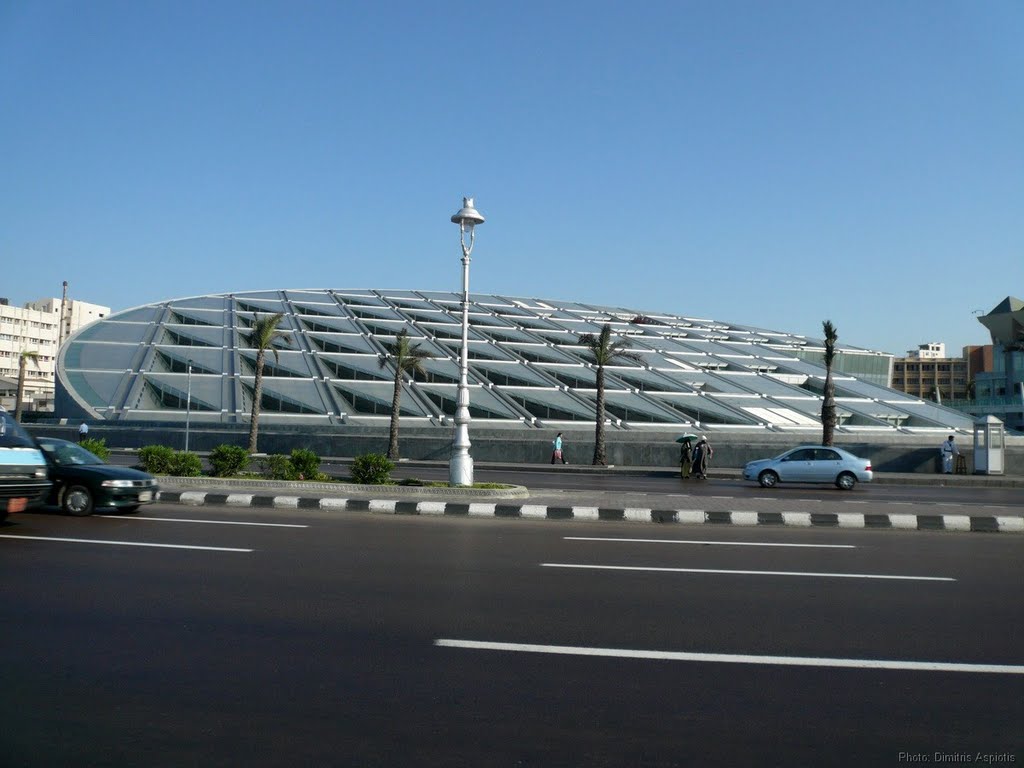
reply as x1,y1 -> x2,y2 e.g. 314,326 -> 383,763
743,445 -> 872,490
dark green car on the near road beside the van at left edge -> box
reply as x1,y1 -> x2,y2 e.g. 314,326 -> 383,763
36,437 -> 160,516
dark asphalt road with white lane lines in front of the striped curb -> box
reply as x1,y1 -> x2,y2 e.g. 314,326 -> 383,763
0,505 -> 1024,766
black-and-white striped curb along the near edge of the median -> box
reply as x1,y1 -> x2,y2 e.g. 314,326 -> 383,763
153,490 -> 1024,534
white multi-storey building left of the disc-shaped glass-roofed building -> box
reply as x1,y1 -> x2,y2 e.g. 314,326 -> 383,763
0,298 -> 111,411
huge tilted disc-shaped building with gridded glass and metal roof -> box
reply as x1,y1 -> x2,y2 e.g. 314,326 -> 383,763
56,289 -> 972,433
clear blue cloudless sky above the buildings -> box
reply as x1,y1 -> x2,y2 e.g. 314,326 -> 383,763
0,0 -> 1024,354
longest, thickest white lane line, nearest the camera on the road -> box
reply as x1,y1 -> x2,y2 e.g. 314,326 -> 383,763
434,638 -> 1024,675
